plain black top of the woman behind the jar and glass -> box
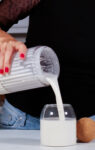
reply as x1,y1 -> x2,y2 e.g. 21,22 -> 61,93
7,0 -> 95,118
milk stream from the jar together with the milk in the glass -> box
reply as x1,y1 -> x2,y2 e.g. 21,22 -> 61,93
40,75 -> 76,146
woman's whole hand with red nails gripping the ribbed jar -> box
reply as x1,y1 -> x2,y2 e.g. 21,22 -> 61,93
0,29 -> 27,75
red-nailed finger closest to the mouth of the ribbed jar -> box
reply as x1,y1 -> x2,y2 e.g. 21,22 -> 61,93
14,42 -> 27,59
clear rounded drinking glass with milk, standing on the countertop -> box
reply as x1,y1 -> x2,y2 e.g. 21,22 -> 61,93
40,104 -> 76,146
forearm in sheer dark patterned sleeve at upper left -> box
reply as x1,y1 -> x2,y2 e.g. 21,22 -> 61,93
0,0 -> 40,31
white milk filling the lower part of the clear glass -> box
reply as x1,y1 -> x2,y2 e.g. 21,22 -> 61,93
40,118 -> 76,146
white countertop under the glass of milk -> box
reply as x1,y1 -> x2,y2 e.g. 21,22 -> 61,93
0,130 -> 95,150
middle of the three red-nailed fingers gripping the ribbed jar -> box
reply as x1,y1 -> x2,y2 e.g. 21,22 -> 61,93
4,44 -> 15,74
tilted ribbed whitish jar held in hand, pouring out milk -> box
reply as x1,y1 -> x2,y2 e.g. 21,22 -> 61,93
0,46 -> 60,94
